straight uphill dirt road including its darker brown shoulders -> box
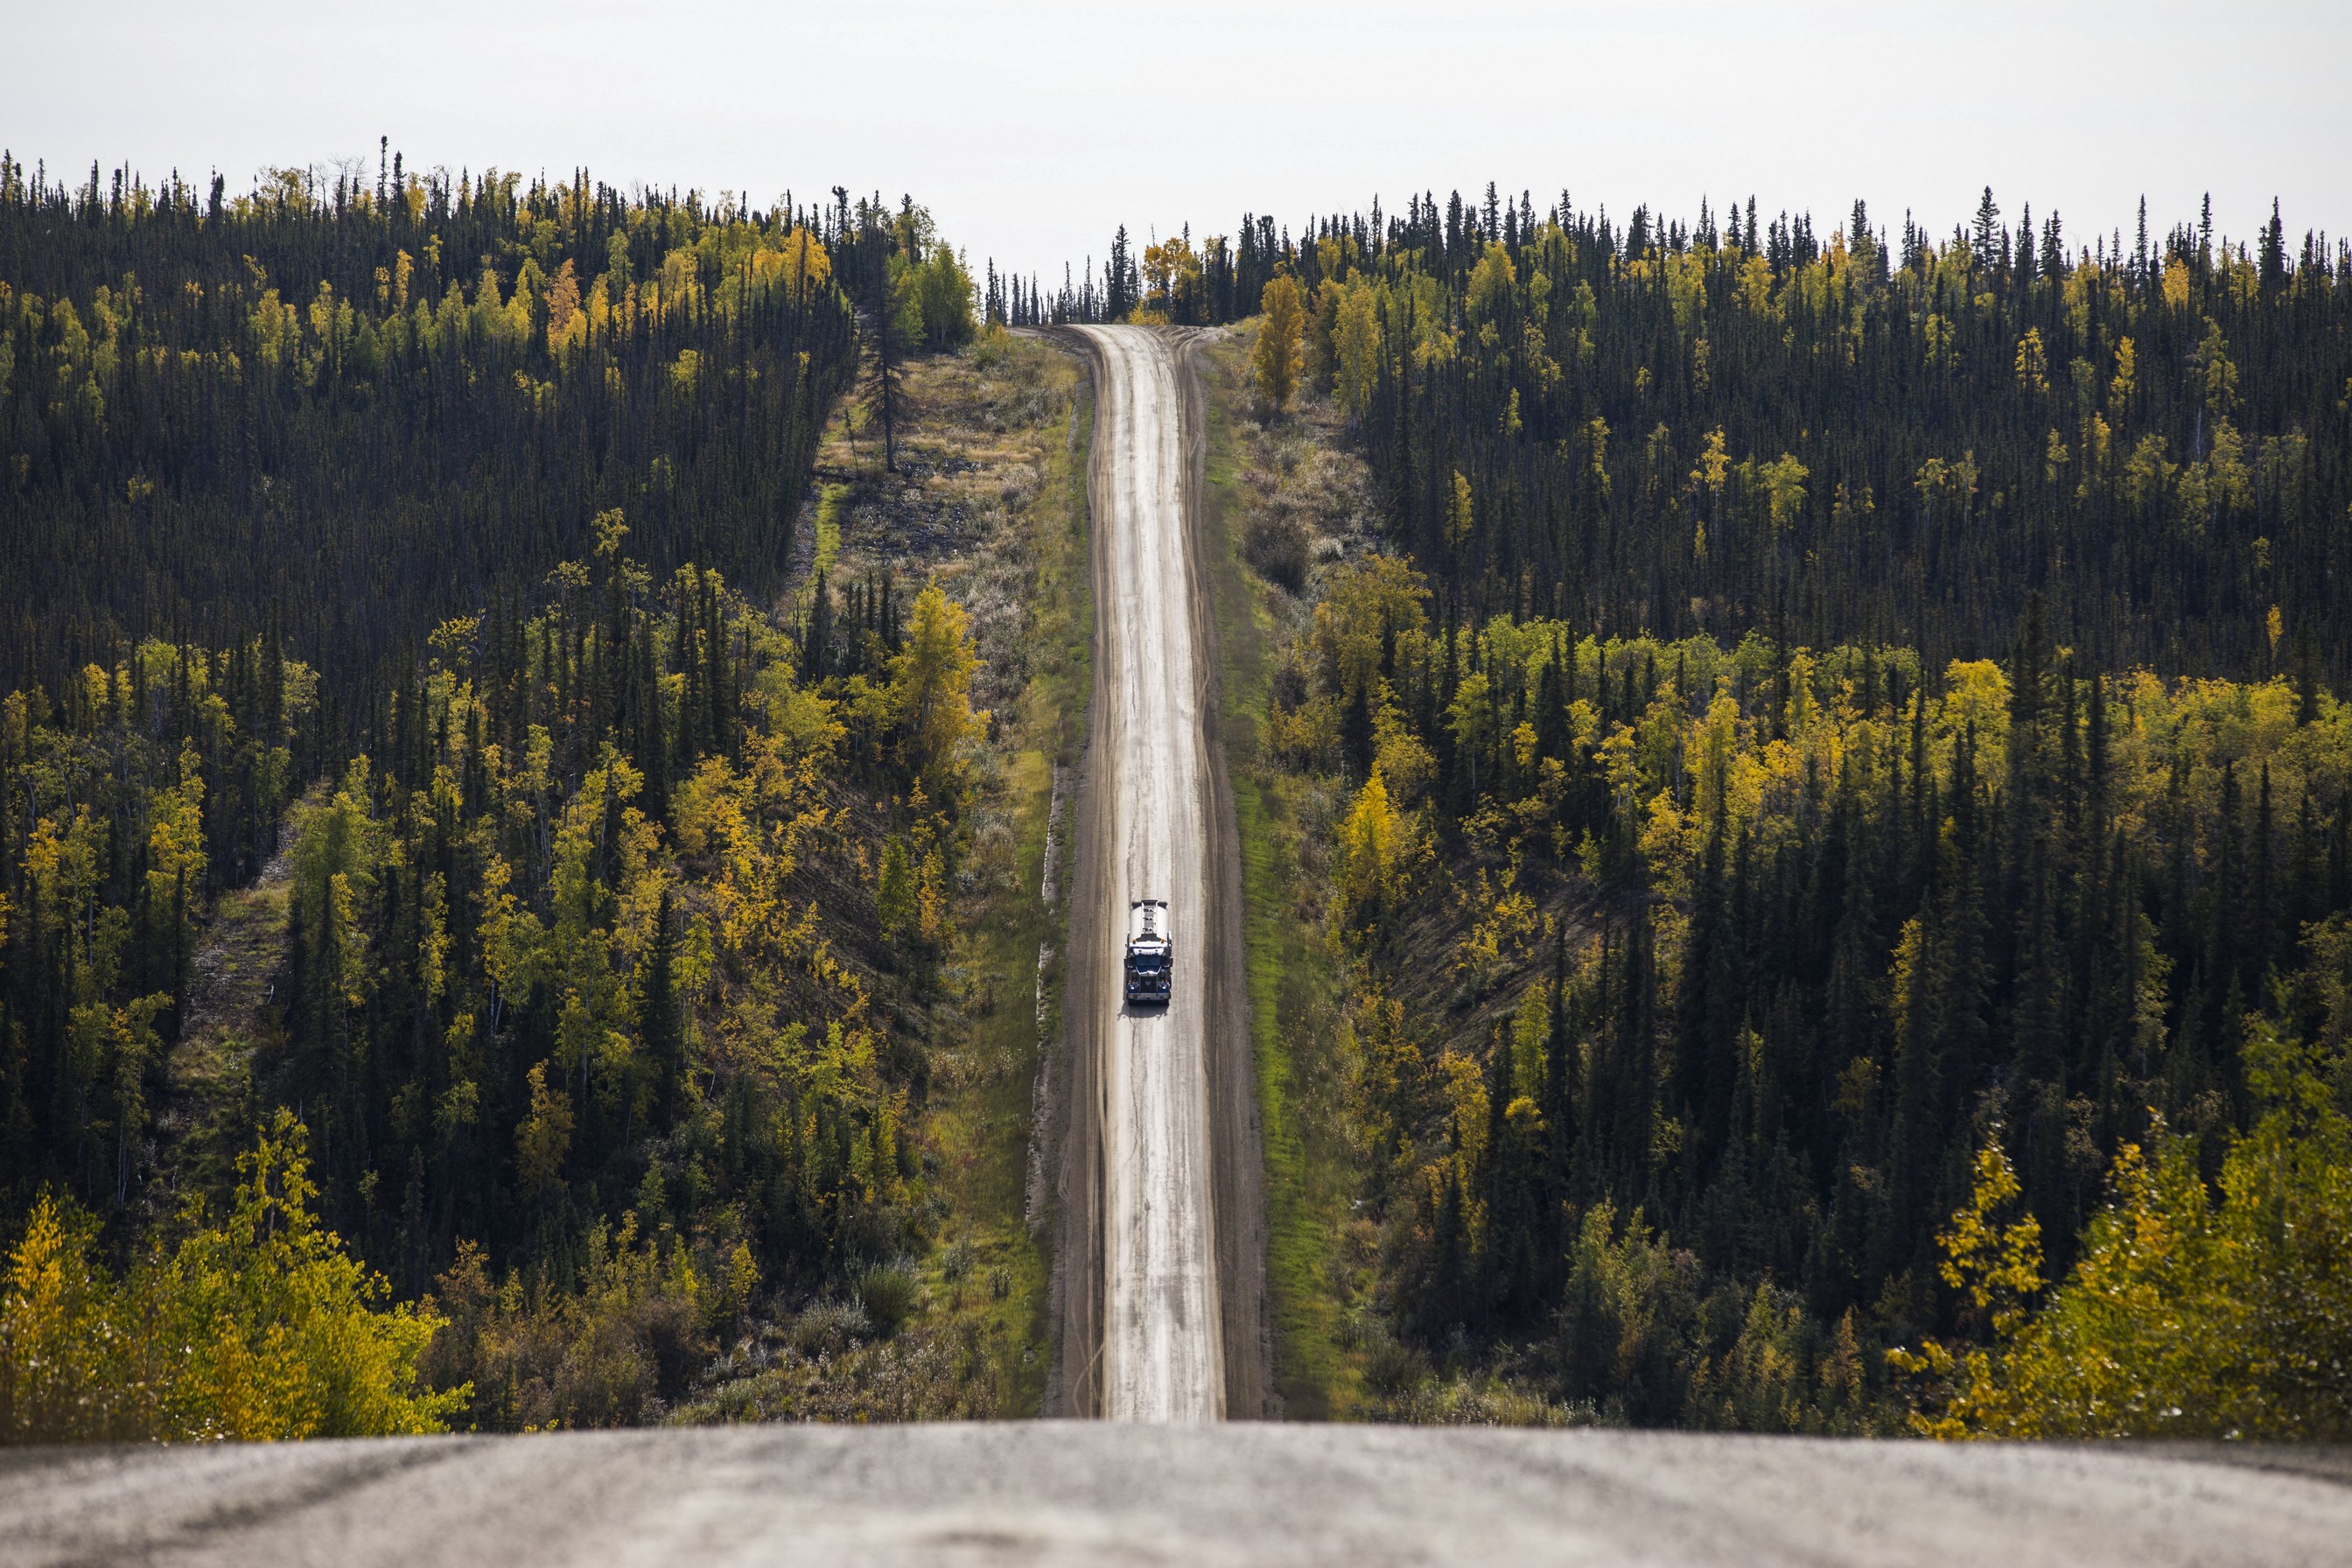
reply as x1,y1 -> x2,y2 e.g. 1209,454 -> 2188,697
1049,326 -> 1263,1422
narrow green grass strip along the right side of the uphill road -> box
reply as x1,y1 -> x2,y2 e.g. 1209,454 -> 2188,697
1204,341 -> 1362,1420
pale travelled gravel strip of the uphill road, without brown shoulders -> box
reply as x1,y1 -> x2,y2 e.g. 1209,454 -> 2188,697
1070,326 -> 1228,1422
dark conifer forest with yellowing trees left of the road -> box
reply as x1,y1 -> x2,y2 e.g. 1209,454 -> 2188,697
0,160 -> 997,1437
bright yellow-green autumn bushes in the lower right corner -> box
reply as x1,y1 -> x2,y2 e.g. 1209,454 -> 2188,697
1891,1018 -> 2352,1441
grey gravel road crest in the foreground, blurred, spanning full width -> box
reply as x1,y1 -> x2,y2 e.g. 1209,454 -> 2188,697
0,1422 -> 2352,1568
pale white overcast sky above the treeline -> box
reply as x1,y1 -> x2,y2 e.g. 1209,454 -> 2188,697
0,0 -> 2352,280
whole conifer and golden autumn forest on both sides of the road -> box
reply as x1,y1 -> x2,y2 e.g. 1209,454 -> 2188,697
0,146 -> 2352,1441
